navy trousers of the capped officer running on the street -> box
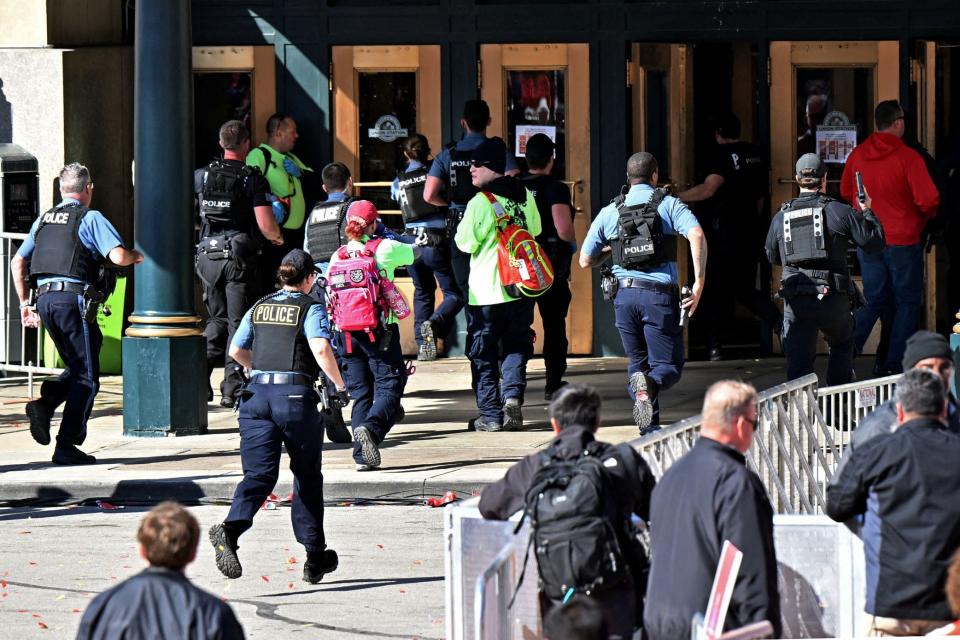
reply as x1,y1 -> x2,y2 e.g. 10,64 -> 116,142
225,384 -> 327,552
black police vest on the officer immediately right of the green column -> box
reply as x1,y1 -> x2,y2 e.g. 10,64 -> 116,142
200,160 -> 254,232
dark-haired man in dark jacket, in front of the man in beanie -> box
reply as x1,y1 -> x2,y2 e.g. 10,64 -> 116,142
826,369 -> 960,636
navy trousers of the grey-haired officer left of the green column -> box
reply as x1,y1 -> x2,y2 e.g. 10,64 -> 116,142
37,291 -> 103,445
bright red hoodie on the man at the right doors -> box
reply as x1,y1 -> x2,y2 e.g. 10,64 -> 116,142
840,131 -> 940,245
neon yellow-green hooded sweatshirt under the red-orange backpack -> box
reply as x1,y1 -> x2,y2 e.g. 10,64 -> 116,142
455,176 -> 541,306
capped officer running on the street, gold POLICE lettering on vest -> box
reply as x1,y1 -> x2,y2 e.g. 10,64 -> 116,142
210,249 -> 347,583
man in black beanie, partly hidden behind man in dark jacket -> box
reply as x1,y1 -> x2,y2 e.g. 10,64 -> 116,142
848,330 -> 960,450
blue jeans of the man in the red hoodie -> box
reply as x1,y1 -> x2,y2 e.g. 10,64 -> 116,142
854,244 -> 923,371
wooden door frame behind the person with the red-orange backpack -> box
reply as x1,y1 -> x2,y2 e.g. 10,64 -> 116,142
480,43 -> 593,355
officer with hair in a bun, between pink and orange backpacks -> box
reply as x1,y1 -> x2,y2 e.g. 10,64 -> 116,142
390,133 -> 464,360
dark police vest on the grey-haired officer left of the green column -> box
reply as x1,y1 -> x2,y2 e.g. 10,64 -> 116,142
30,204 -> 103,286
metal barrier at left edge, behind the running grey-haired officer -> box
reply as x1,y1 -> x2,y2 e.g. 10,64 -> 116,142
0,233 -> 63,398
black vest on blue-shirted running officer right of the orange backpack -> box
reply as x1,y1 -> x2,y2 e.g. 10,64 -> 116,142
610,189 -> 677,271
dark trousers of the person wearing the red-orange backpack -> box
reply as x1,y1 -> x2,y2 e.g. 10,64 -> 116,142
467,299 -> 533,424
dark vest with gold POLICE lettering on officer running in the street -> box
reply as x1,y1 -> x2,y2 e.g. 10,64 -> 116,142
250,293 -> 320,379
